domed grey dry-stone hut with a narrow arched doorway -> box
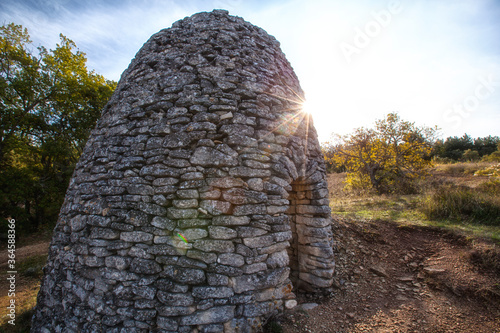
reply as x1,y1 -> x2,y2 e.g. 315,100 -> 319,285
32,10 -> 334,333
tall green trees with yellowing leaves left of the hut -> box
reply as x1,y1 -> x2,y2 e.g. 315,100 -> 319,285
0,23 -> 116,230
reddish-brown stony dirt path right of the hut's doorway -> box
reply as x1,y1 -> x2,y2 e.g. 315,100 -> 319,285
278,220 -> 500,333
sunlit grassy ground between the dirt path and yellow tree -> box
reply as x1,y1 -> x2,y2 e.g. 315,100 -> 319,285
328,163 -> 500,243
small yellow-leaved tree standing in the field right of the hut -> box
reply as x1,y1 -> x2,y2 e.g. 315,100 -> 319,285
331,113 -> 437,193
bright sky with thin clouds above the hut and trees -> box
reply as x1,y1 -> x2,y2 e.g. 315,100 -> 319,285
0,0 -> 500,141
